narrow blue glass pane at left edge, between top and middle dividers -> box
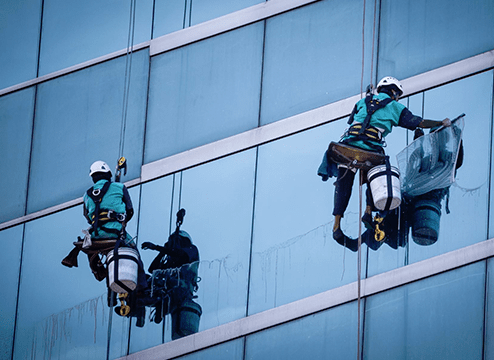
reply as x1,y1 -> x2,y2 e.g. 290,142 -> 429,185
0,88 -> 34,223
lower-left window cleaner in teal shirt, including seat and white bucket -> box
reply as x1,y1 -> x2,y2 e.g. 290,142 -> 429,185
62,157 -> 146,326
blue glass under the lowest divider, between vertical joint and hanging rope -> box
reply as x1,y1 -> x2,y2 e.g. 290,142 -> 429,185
245,302 -> 358,360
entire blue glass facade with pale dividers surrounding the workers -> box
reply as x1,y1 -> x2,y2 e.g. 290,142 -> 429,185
0,0 -> 494,359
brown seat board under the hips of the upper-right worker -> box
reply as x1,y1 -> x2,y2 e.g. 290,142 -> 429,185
327,141 -> 386,170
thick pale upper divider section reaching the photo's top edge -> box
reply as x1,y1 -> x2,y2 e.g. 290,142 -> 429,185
149,0 -> 320,56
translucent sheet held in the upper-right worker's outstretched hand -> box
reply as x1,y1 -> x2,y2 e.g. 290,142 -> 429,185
396,114 -> 465,197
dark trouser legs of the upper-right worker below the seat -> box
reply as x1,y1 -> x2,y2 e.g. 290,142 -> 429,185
333,167 -> 374,217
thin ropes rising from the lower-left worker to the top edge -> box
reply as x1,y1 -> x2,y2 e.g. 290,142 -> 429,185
118,0 -> 136,158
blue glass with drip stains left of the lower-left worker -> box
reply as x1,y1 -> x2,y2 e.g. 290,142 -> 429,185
13,206 -> 109,360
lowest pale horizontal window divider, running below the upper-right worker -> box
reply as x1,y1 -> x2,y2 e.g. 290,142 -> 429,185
116,239 -> 494,360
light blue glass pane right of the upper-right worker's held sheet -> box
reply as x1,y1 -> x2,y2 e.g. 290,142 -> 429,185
410,71 -> 493,262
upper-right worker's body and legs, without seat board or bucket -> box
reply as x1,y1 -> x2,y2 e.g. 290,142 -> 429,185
333,76 -> 451,244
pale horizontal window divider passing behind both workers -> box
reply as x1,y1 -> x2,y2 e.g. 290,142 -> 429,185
0,48 -> 494,231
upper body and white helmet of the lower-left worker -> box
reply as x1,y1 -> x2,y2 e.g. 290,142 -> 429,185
83,161 -> 135,247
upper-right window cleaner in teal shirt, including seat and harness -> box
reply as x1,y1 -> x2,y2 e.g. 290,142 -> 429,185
318,76 -> 451,251
